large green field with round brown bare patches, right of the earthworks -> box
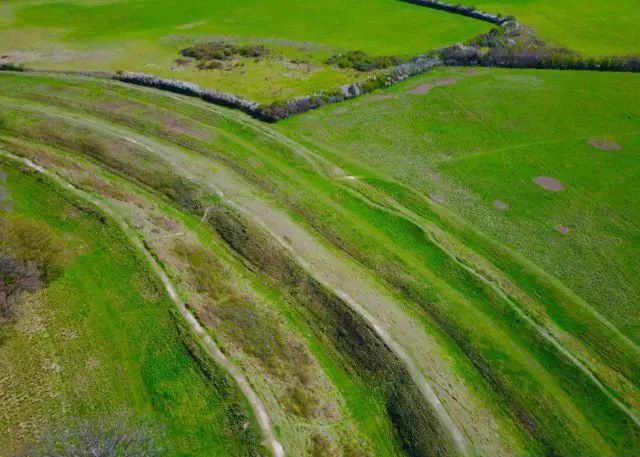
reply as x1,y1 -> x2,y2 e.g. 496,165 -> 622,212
278,69 -> 640,341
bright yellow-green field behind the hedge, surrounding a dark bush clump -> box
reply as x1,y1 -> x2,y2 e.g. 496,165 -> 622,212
0,0 -> 489,101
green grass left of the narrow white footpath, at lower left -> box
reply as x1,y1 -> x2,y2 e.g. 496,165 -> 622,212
0,160 -> 261,457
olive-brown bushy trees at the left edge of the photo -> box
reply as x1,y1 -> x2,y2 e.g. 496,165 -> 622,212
0,217 -> 66,318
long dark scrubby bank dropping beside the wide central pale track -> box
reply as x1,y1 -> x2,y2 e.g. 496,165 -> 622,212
207,206 -> 454,456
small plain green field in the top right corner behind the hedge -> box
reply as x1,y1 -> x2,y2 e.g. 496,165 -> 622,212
470,0 -> 640,56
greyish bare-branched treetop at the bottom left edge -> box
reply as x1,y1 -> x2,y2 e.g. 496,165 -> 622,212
23,410 -> 164,457
